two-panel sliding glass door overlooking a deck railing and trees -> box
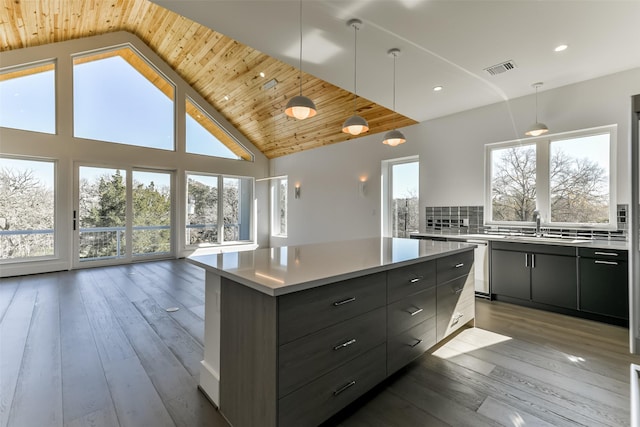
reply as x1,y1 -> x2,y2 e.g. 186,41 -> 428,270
73,165 -> 173,267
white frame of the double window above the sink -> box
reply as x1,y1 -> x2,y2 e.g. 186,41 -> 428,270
484,125 -> 618,230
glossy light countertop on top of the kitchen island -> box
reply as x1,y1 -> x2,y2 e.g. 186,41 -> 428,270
188,237 -> 474,296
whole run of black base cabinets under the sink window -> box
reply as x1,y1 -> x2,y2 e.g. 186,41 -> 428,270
491,242 -> 629,324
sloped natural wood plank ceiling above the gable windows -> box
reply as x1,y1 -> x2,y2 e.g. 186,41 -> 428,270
0,0 -> 416,158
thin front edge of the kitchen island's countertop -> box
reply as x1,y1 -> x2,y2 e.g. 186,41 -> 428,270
186,242 -> 476,297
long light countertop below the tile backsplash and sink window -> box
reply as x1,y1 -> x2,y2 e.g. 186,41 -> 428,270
411,233 -> 629,251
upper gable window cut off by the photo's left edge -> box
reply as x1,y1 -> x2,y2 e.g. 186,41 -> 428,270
0,62 -> 56,134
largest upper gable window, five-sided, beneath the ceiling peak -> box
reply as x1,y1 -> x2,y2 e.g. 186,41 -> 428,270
73,47 -> 175,150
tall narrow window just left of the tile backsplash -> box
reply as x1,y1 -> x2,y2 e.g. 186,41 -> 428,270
382,156 -> 420,237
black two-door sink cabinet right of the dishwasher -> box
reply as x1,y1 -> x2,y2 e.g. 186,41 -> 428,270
491,242 -> 578,310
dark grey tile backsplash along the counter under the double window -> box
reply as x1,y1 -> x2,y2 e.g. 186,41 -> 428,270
425,204 -> 628,241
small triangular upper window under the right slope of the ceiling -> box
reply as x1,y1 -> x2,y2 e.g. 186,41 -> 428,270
186,99 -> 252,160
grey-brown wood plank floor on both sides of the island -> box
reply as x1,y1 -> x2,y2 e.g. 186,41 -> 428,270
0,260 -> 640,427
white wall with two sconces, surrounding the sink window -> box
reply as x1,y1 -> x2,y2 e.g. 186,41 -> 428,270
271,68 -> 640,246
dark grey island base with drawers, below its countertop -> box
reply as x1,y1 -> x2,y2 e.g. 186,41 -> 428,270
220,248 -> 475,427
